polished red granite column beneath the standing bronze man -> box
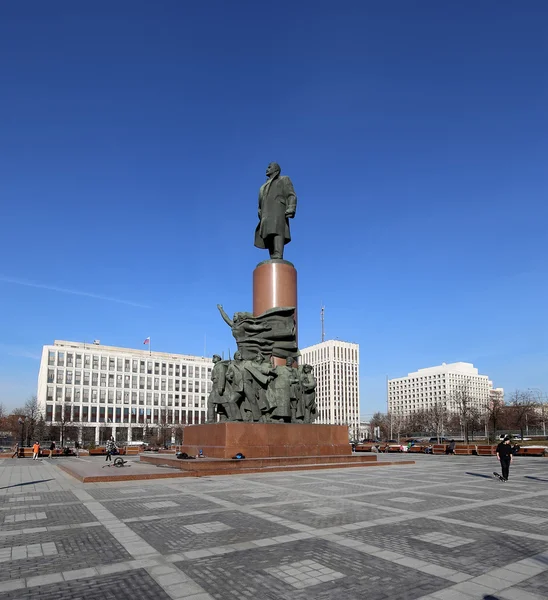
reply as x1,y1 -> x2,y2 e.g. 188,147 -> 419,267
253,259 -> 297,365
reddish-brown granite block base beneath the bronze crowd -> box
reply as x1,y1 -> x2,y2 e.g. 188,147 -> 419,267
181,422 -> 352,458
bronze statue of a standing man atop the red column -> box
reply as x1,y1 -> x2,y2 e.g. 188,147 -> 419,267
255,163 -> 297,260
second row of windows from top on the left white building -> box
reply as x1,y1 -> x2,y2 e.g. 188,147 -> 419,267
47,369 -> 212,394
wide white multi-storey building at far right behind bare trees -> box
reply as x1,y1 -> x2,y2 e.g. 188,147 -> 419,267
388,362 -> 490,416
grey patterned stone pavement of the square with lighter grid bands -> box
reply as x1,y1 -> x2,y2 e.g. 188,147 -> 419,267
0,455 -> 548,600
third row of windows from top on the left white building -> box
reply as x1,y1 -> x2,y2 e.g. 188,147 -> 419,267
46,387 -> 206,408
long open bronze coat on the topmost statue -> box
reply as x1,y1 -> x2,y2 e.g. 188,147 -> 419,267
255,175 -> 297,249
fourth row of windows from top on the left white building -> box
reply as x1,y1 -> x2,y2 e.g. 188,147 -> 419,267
46,404 -> 206,425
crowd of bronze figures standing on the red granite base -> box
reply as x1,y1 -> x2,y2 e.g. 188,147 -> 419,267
208,351 -> 316,423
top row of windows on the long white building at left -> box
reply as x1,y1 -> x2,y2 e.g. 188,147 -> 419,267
48,350 -> 211,379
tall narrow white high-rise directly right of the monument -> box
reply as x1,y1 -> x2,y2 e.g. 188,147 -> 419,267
299,340 -> 360,437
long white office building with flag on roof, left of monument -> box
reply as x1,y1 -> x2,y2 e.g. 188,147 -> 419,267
37,340 -> 213,443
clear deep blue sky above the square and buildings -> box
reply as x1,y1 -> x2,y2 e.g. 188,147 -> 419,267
0,0 -> 548,415
